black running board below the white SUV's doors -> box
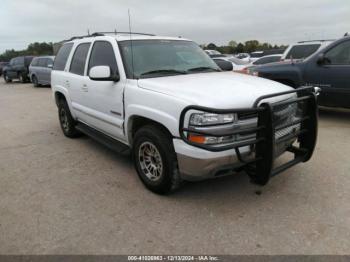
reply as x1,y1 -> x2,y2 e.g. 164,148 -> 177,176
75,123 -> 130,155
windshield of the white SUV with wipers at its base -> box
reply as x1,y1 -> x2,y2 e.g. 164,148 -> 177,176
118,40 -> 220,79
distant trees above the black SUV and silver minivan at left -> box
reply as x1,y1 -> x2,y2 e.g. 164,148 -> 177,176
0,42 -> 53,61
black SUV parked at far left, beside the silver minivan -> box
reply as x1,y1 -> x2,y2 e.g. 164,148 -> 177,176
3,56 -> 33,83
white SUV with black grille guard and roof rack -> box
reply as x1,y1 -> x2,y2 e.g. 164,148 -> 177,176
51,33 -> 317,194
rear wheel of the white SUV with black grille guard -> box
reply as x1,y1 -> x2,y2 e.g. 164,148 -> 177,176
58,99 -> 81,138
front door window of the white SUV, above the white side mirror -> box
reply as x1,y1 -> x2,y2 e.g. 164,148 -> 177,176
89,41 -> 118,73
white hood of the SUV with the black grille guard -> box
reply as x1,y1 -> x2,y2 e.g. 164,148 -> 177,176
138,72 -> 292,109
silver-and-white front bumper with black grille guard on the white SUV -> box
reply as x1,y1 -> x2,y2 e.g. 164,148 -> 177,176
178,87 -> 318,185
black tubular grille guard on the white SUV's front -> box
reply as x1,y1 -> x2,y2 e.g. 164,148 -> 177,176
179,87 -> 318,185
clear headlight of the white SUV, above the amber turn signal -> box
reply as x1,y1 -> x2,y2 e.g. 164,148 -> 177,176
189,113 -> 236,126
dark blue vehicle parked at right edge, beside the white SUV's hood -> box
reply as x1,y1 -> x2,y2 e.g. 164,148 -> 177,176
250,36 -> 350,108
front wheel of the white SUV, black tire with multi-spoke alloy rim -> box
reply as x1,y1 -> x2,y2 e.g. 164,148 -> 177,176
133,125 -> 181,195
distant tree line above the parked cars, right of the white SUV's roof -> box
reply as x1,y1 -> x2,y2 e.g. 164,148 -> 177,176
202,40 -> 287,54
